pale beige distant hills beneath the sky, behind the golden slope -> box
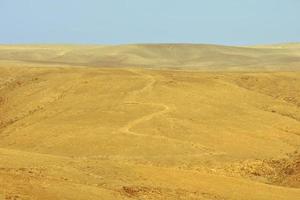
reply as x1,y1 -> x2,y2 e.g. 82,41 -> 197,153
0,44 -> 300,70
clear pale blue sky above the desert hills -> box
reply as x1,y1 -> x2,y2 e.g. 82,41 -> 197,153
0,0 -> 300,45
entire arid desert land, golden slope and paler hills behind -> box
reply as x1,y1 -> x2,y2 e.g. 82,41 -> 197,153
0,44 -> 300,200
